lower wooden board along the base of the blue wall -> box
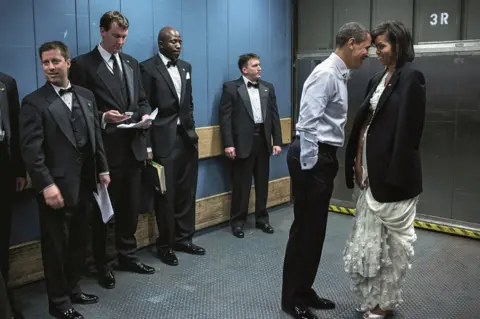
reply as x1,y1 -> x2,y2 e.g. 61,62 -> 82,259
9,176 -> 290,287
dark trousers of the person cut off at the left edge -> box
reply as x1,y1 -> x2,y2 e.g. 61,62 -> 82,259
0,142 -> 15,316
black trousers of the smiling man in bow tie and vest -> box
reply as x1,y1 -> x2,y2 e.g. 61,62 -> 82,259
37,185 -> 94,310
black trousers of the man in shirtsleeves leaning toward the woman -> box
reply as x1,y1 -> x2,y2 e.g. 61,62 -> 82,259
282,138 -> 338,307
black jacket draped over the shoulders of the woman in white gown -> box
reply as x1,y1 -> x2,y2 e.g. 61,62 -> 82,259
345,62 -> 426,202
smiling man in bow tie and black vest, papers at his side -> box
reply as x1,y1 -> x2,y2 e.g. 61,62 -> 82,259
19,41 -> 110,319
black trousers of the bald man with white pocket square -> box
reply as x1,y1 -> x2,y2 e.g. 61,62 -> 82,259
155,127 -> 198,249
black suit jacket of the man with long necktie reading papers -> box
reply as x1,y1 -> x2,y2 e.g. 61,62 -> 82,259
69,47 -> 151,166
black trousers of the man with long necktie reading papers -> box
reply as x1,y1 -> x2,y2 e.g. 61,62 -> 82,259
92,154 -> 144,272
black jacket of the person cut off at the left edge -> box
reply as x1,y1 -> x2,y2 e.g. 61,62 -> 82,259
0,72 -> 26,177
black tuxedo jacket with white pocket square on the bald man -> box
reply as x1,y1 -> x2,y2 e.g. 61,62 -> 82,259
140,54 -> 198,158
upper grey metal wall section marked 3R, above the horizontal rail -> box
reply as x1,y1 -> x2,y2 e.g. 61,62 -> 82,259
297,0 -> 480,53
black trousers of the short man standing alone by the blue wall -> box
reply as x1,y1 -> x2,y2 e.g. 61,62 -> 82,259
230,125 -> 270,227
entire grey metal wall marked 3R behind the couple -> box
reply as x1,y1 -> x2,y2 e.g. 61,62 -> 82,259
293,0 -> 480,228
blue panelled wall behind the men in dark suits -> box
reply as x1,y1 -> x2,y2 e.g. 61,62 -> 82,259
0,0 -> 291,244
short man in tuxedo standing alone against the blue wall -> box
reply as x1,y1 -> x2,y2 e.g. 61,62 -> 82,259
219,53 -> 282,238
